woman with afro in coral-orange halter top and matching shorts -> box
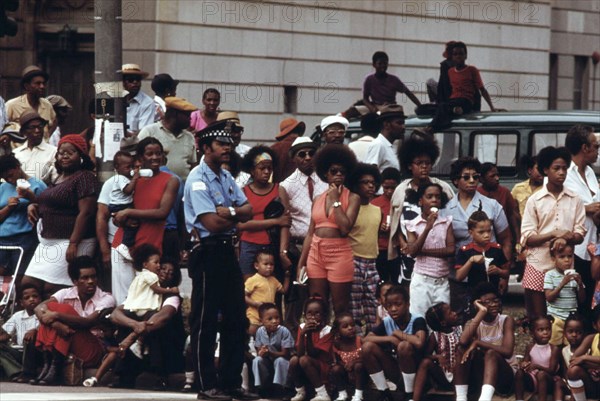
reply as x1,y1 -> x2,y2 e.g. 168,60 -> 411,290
298,144 -> 360,315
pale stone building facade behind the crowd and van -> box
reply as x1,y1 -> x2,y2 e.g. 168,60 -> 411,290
0,0 -> 600,142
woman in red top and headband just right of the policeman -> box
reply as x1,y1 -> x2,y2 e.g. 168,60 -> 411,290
238,146 -> 292,280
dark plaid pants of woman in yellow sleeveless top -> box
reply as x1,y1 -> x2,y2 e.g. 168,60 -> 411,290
350,256 -> 379,333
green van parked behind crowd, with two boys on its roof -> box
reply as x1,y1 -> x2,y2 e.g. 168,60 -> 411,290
346,110 -> 600,188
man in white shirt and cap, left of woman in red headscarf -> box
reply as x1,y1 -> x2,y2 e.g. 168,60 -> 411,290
14,111 -> 56,183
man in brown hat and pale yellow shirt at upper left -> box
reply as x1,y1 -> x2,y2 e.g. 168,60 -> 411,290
6,65 -> 56,142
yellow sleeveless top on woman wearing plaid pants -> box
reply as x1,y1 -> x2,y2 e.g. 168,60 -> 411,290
349,204 -> 381,259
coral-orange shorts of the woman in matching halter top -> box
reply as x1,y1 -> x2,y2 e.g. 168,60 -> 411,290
306,235 -> 354,283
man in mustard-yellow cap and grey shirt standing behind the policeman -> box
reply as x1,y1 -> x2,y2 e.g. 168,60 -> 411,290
138,96 -> 198,180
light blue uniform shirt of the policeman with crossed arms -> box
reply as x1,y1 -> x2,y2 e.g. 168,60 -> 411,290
184,160 -> 248,238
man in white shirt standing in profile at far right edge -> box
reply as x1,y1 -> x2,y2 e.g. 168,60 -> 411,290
564,125 -> 600,313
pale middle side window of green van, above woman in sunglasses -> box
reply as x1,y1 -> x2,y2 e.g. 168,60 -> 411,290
471,131 -> 519,170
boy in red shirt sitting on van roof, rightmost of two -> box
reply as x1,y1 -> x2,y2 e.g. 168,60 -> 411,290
430,42 -> 496,132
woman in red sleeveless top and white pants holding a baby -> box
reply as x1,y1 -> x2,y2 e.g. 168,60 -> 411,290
111,137 -> 179,304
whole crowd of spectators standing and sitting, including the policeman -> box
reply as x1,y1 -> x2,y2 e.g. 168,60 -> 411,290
0,42 -> 600,401
